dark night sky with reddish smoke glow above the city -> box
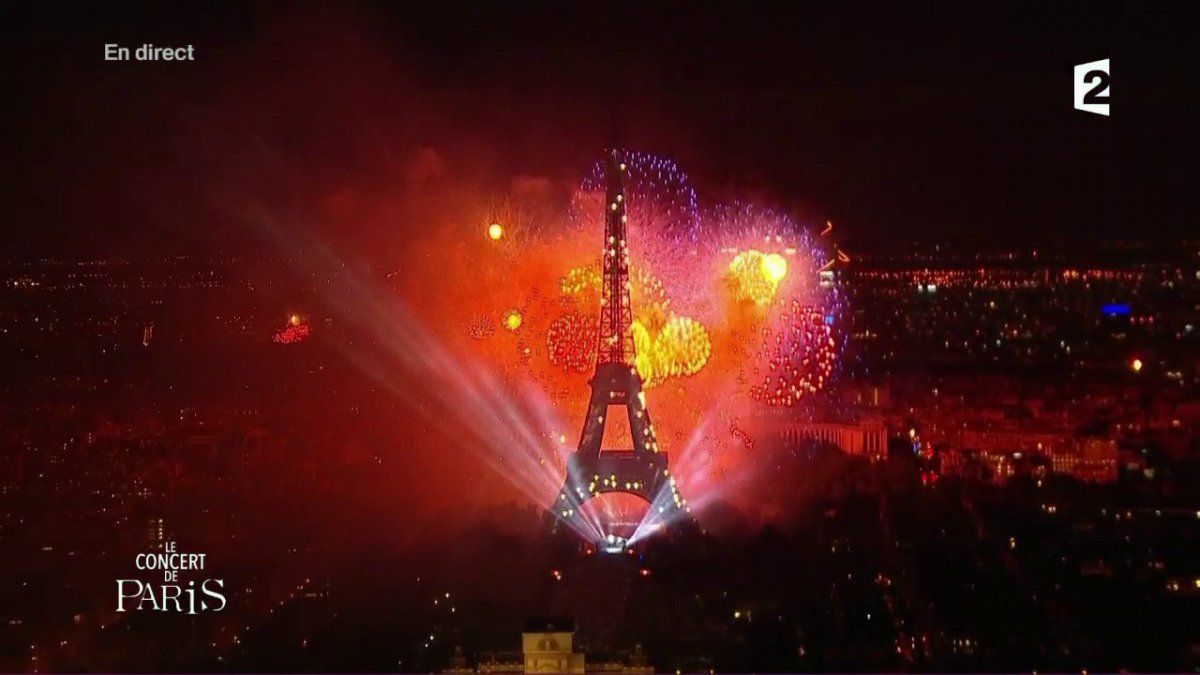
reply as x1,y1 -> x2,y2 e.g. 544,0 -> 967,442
0,2 -> 1200,259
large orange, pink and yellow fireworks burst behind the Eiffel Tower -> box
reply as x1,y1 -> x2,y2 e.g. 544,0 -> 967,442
400,153 -> 844,535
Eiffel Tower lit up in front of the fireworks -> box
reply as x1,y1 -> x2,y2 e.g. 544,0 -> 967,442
553,149 -> 685,542
